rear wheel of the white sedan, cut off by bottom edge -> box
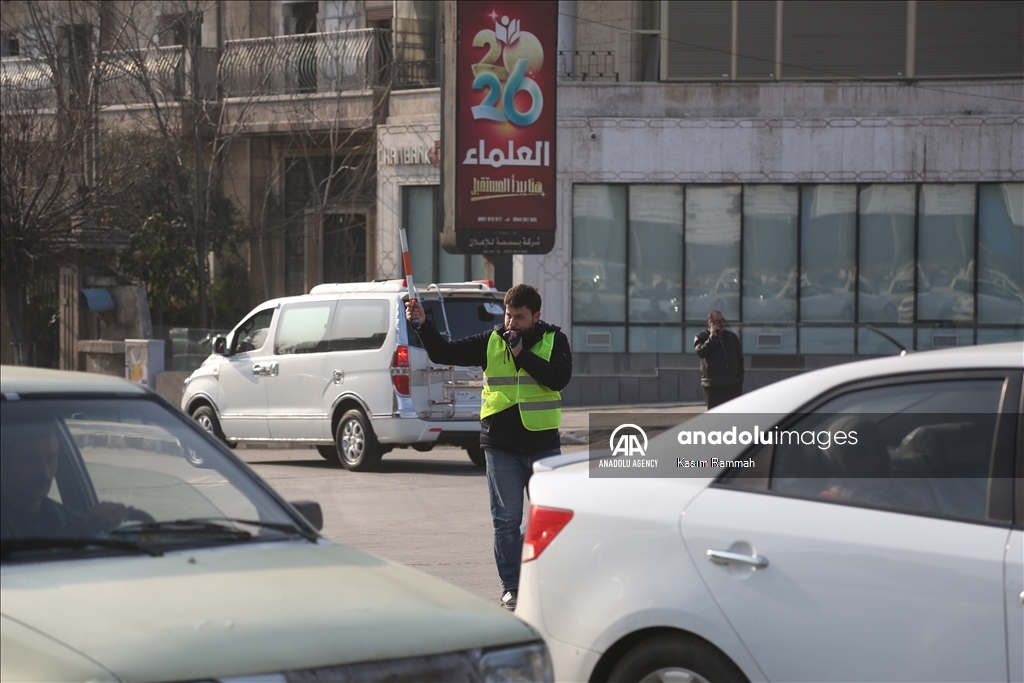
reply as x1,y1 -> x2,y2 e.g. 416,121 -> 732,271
607,634 -> 748,683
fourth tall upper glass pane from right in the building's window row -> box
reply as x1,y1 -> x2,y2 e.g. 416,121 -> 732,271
800,185 -> 857,325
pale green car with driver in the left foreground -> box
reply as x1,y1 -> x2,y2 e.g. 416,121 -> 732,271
0,367 -> 552,683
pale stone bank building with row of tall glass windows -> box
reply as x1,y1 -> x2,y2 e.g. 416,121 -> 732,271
378,1 -> 1024,404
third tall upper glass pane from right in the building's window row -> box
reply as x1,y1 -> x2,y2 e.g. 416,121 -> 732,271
858,185 -> 916,325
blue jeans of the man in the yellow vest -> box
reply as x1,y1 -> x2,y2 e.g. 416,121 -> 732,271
483,446 -> 561,591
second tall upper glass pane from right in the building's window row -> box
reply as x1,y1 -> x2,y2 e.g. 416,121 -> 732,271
918,184 -> 975,321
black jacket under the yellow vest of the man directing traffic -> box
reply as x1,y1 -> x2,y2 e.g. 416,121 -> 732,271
417,319 -> 572,455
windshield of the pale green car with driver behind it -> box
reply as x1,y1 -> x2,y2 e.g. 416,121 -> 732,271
0,396 -> 315,562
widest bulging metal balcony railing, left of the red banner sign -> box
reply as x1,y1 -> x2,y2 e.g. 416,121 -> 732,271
219,29 -> 390,97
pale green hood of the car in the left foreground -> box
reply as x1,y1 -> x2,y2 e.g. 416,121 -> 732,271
0,542 -> 539,681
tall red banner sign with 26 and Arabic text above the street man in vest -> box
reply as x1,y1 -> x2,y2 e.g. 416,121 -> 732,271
454,0 -> 558,254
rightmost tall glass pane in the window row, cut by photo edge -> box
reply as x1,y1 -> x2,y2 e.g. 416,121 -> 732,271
978,182 -> 1024,325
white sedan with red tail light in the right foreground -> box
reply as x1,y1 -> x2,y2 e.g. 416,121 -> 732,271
516,343 -> 1024,683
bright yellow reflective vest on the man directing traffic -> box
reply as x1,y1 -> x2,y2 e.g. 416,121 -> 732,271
480,331 -> 562,431
